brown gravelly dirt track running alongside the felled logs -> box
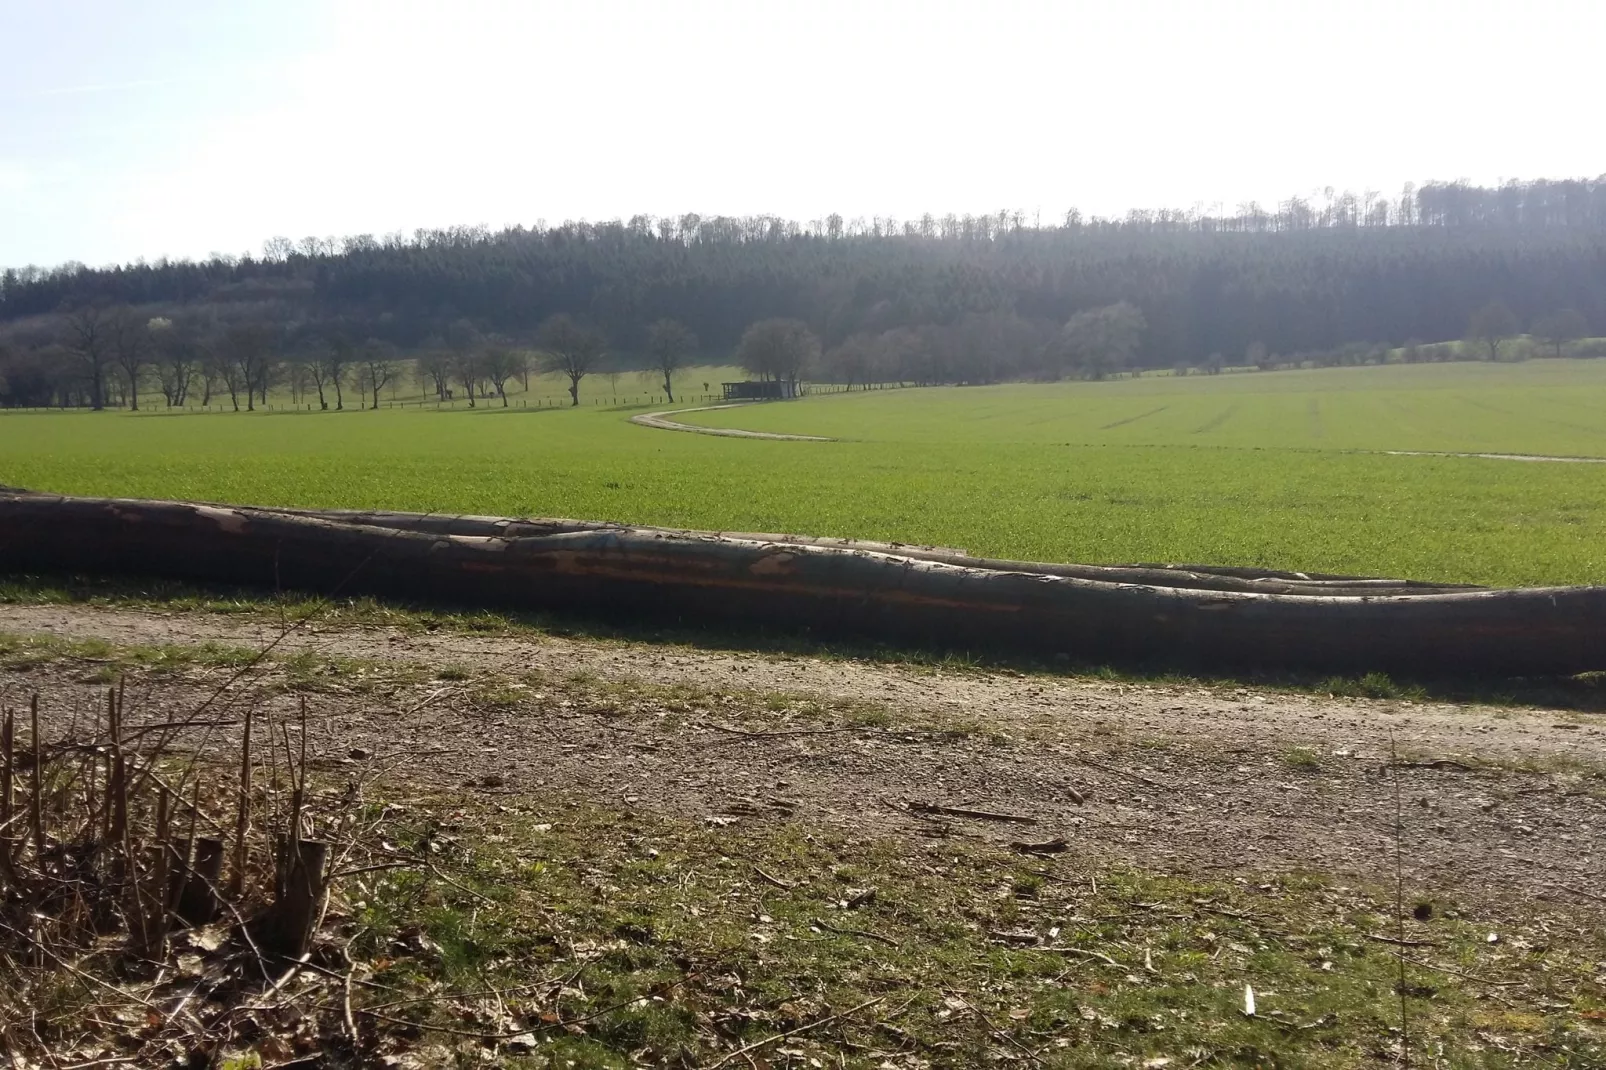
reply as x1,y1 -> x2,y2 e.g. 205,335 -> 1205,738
0,606 -> 1606,895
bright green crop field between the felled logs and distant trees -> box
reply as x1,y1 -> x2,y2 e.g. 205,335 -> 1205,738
0,360 -> 1606,585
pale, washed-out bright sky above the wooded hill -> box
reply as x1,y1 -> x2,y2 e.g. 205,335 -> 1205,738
0,0 -> 1606,265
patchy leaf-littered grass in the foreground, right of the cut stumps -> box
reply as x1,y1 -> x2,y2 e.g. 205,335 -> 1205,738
329,797 -> 1603,1070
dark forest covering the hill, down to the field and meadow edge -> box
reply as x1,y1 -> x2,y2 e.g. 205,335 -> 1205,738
0,177 -> 1606,405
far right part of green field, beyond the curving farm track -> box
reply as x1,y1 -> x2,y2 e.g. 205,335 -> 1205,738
686,360 -> 1606,456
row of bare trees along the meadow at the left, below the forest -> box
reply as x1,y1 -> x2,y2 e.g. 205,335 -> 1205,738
0,305 -> 824,411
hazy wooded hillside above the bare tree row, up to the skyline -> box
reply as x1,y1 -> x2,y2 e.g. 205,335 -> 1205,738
9,180 -> 1606,381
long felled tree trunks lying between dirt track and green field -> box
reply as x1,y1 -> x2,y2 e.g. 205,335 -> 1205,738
0,493 -> 1606,675
